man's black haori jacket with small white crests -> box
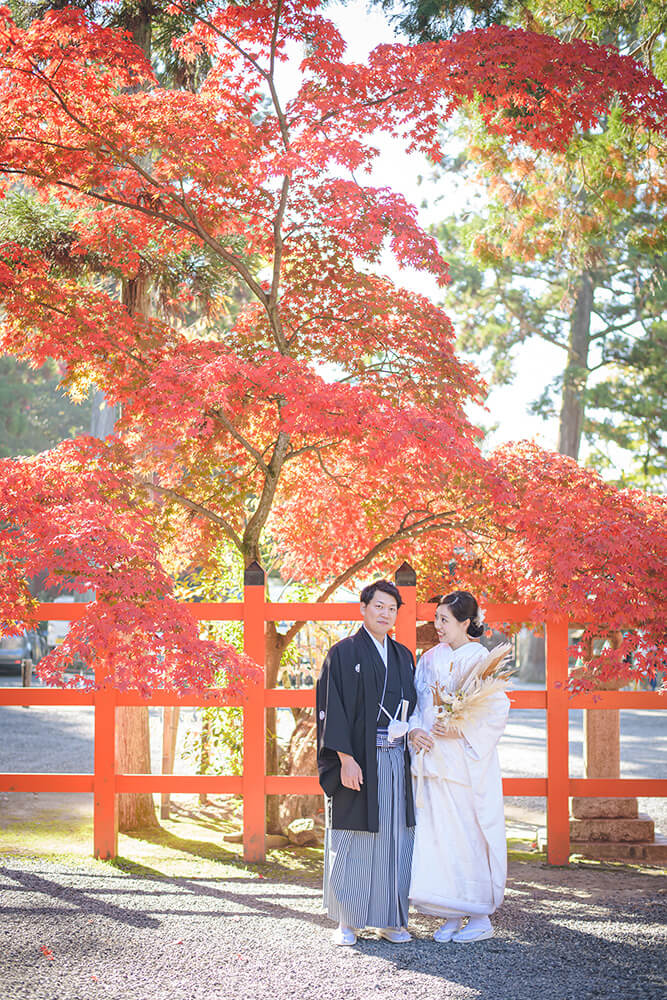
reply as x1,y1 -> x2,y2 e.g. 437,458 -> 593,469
316,628 -> 417,833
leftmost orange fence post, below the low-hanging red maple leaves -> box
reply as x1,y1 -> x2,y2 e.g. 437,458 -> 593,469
93,668 -> 118,858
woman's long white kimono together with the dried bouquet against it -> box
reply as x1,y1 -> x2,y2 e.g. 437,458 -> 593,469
410,642 -> 511,917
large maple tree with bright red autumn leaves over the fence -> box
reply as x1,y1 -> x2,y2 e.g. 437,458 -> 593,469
0,0 -> 667,689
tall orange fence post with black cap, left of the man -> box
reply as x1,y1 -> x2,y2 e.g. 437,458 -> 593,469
243,562 -> 266,861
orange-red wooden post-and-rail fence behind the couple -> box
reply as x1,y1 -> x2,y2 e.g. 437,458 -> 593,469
0,563 -> 667,865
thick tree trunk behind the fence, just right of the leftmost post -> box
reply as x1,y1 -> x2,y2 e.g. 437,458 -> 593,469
116,705 -> 158,831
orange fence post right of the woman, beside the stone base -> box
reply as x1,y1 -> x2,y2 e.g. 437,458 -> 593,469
546,618 -> 570,865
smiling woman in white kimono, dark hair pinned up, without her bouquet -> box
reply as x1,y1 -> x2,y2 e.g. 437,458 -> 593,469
409,591 -> 509,942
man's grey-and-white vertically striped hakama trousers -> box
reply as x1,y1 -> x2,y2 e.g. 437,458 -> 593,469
324,734 -> 415,928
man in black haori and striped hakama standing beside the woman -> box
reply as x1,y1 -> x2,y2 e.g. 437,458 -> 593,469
317,580 -> 417,945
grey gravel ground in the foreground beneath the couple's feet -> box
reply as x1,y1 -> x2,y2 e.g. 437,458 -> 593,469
0,857 -> 667,1000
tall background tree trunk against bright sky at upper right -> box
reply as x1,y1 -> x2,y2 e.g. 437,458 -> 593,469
558,271 -> 595,458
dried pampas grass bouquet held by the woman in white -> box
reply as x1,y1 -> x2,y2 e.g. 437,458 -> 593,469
431,642 -> 513,733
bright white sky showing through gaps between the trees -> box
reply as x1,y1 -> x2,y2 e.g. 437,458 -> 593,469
326,0 -> 562,448
